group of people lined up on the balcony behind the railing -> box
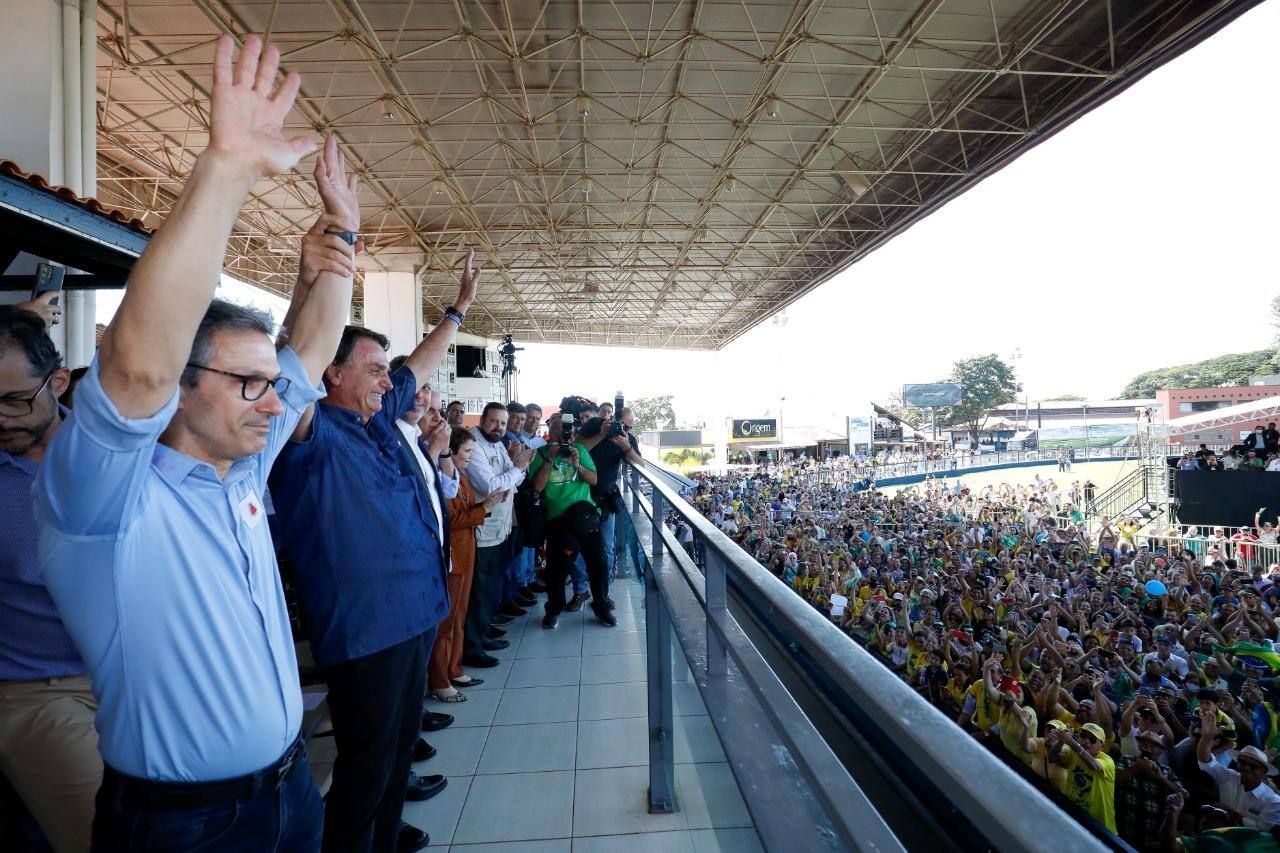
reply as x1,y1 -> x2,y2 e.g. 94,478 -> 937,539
0,36 -> 641,853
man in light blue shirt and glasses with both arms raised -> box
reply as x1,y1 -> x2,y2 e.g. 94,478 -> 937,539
35,31 -> 358,850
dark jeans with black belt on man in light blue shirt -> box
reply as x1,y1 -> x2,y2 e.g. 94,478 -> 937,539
92,732 -> 324,853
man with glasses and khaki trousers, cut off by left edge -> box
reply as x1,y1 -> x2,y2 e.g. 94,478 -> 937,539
0,302 -> 102,850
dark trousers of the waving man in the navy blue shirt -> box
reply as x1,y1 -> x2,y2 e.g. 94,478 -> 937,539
324,628 -> 435,853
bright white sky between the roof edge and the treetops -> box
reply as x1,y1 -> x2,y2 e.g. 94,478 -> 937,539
518,3 -> 1280,432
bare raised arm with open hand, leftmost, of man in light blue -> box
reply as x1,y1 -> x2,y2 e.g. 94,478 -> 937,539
99,36 -> 316,418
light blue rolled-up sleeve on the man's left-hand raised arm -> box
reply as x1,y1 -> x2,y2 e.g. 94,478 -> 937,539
35,357 -> 178,537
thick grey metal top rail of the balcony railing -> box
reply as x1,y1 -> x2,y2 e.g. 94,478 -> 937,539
624,469 -> 1103,850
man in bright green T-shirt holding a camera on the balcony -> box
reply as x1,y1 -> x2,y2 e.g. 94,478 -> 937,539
529,415 -> 618,629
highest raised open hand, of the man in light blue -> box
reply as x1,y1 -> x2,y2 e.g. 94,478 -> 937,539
209,36 -> 316,177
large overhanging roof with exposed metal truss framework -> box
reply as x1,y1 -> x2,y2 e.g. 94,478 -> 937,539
87,0 -> 1260,348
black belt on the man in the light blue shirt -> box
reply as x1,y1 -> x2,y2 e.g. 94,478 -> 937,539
102,735 -> 306,811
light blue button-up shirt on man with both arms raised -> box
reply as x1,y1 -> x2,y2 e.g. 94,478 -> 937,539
36,348 -> 324,781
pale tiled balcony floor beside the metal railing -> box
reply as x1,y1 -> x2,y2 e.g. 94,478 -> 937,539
404,580 -> 760,853
